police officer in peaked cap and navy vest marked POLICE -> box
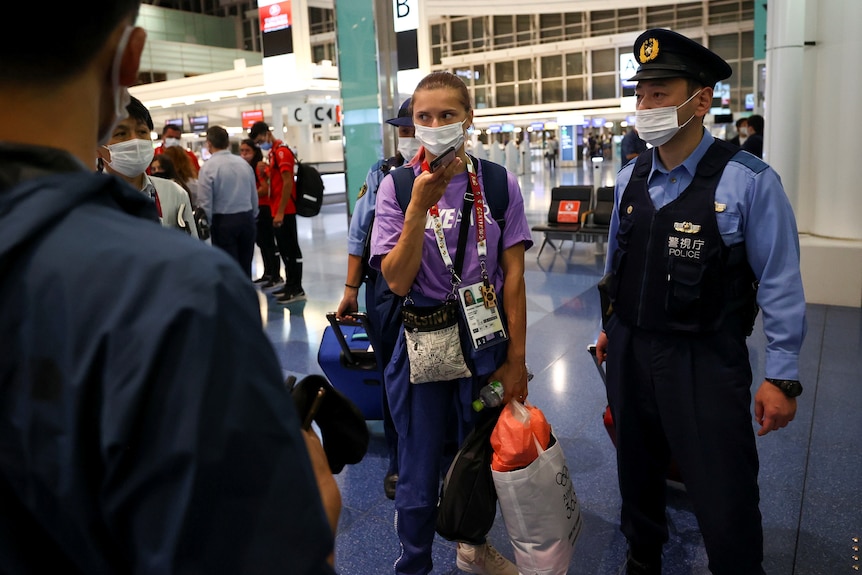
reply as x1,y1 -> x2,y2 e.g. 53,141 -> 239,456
597,29 -> 806,575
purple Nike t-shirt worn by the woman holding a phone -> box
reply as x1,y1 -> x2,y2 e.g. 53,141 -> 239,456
371,164 -> 533,301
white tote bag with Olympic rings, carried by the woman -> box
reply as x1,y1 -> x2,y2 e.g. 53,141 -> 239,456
491,433 -> 582,575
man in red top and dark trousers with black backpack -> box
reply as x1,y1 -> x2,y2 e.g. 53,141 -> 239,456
248,122 -> 305,304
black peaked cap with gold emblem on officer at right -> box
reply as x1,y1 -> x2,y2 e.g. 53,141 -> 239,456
631,28 -> 732,87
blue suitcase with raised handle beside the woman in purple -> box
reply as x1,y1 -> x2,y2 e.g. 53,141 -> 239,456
317,312 -> 383,419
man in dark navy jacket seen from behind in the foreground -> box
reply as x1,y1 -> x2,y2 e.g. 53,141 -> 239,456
0,0 -> 341,575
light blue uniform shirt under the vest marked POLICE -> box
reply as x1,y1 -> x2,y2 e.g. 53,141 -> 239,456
605,129 -> 807,379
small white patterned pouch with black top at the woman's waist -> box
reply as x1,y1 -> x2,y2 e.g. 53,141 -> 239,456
401,302 -> 472,383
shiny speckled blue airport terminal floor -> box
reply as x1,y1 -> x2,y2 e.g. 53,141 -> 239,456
253,158 -> 862,575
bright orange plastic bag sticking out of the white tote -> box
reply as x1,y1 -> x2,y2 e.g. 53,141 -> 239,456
491,401 -> 551,471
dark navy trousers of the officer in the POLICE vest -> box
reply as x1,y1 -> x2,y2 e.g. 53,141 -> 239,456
607,318 -> 763,575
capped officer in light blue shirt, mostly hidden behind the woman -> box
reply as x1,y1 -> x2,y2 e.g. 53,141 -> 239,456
336,98 -> 419,499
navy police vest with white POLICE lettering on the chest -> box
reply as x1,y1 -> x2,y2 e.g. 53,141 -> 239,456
610,140 -> 756,333
